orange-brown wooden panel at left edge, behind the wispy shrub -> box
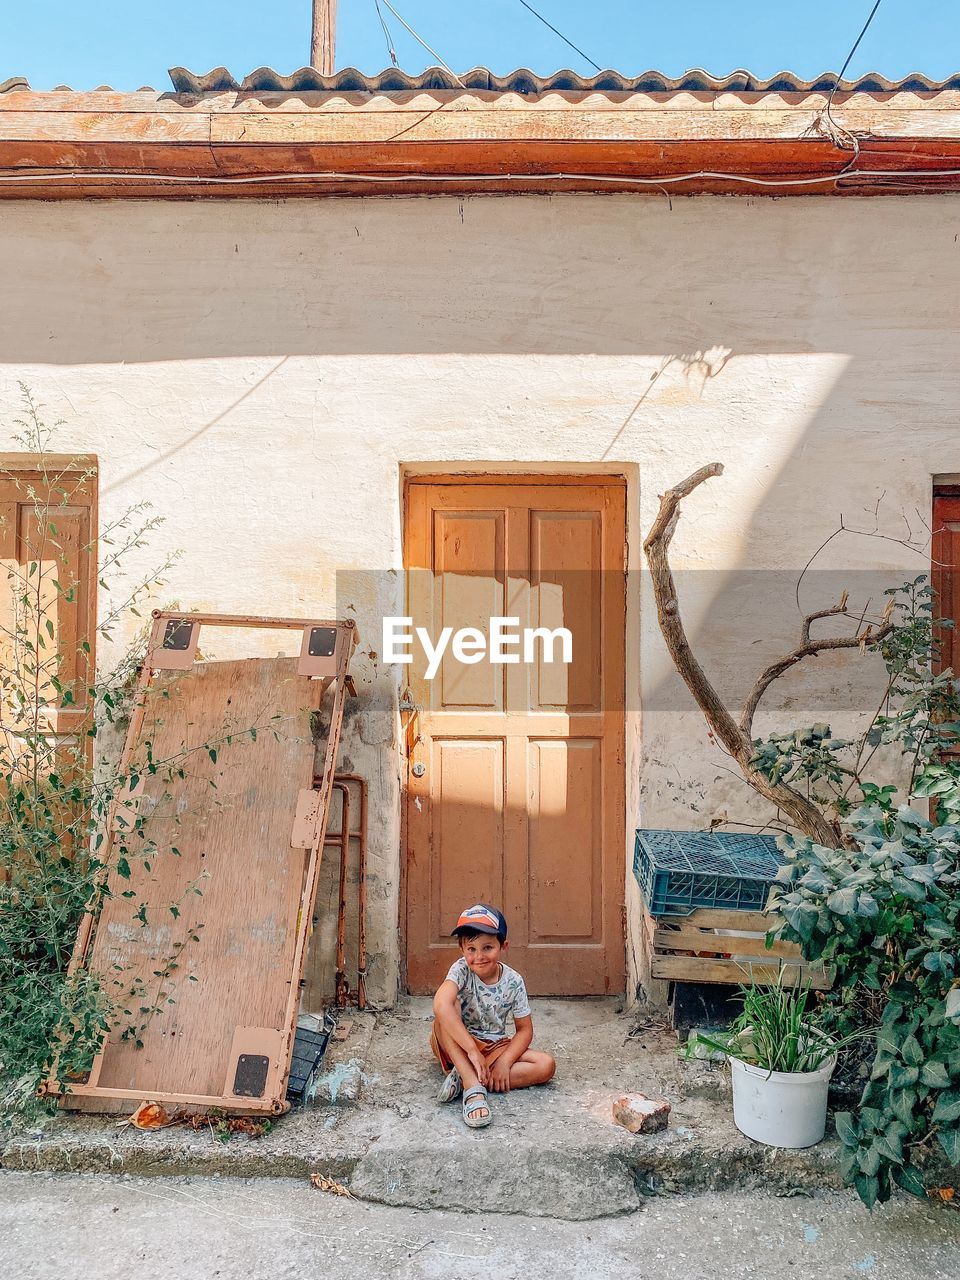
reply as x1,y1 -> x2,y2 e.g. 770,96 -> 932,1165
0,453 -> 97,763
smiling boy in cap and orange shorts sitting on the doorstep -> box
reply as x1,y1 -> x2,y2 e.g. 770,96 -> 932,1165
430,902 -> 557,1129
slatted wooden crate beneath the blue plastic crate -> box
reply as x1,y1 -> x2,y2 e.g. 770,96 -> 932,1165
646,909 -> 833,991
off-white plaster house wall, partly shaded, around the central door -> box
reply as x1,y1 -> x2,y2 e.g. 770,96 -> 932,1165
0,196 -> 960,1002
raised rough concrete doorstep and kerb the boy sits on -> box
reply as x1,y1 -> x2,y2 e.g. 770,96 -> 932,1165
0,1000 -> 957,1221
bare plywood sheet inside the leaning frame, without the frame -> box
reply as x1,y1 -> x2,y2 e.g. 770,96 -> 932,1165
60,658 -> 319,1098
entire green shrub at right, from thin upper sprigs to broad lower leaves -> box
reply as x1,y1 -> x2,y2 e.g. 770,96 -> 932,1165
753,577 -> 960,1206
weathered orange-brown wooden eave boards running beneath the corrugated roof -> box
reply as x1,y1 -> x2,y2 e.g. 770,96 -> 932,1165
0,88 -> 960,198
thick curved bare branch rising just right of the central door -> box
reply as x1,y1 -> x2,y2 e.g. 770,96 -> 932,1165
644,462 -> 842,849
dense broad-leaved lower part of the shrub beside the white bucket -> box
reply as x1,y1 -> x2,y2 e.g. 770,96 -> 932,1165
774,805 -> 960,1204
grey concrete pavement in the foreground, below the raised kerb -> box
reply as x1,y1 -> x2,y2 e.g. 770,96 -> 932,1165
0,1174 -> 960,1280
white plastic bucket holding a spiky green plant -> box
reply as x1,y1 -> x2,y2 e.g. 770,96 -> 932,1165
730,1057 -> 837,1147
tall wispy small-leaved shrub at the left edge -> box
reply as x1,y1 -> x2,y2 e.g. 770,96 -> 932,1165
0,389 -> 172,1103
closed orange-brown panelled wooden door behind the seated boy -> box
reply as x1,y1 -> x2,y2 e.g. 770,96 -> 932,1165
404,476 -> 626,996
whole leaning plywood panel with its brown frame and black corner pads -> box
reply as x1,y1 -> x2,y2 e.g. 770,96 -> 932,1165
46,613 -> 356,1115
